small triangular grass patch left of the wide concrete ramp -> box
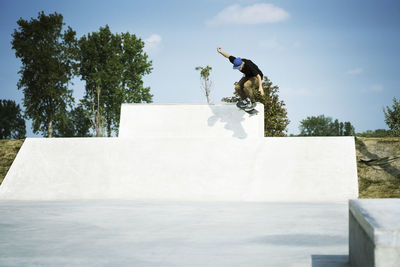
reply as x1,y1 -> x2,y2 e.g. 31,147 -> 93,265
0,140 -> 24,184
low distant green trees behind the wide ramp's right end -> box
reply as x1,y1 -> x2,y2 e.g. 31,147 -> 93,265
299,115 -> 354,136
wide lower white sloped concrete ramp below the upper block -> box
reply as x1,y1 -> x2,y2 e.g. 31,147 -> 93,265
0,137 -> 358,202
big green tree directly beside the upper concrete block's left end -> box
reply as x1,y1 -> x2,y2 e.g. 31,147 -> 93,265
79,25 -> 153,136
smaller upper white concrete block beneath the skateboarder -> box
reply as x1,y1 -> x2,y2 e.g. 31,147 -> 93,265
119,103 -> 264,139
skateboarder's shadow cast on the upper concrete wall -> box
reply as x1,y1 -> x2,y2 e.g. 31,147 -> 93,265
207,105 -> 247,139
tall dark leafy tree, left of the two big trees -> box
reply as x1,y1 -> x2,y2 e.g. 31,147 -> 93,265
11,12 -> 76,137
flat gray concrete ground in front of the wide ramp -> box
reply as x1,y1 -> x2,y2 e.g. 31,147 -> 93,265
0,201 -> 348,267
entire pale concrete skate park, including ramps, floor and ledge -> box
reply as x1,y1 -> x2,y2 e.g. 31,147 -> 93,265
0,104 -> 400,266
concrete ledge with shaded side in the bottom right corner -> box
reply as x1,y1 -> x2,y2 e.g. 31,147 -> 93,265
349,199 -> 400,267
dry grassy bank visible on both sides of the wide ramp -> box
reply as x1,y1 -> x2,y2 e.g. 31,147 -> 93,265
0,137 -> 400,198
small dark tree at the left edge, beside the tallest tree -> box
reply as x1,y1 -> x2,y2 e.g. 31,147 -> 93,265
0,100 -> 26,139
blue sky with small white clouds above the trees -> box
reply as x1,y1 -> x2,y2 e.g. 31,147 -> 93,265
0,0 -> 400,136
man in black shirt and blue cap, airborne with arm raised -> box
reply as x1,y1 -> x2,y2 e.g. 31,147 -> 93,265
217,46 -> 264,110
